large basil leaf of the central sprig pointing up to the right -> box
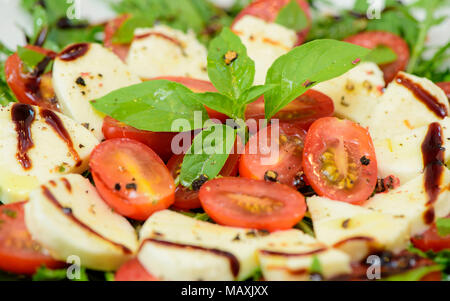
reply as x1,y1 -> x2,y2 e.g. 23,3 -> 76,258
264,40 -> 370,119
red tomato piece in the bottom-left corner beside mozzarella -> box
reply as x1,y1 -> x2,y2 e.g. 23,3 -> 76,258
0,203 -> 64,275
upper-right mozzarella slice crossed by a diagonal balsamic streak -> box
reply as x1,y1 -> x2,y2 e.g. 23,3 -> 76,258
368,72 -> 449,139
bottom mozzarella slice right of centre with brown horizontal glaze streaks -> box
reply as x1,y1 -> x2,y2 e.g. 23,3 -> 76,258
258,230 -> 351,281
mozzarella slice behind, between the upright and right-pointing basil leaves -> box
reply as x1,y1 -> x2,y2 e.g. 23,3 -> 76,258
233,15 -> 297,85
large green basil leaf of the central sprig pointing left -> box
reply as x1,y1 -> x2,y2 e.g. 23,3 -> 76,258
92,80 -> 207,132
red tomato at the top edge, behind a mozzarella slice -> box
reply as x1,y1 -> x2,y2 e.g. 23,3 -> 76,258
232,0 -> 311,45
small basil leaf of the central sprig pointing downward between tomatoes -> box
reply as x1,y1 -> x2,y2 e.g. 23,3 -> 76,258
180,124 -> 236,187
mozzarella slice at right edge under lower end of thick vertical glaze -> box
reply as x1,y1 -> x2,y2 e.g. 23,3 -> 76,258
364,168 -> 450,236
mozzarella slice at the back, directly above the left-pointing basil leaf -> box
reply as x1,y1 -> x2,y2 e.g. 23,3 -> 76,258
127,25 -> 208,80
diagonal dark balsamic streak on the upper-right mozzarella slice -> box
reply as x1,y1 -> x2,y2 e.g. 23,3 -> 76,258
395,74 -> 448,118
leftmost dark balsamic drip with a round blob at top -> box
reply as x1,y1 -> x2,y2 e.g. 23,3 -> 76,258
11,103 -> 36,170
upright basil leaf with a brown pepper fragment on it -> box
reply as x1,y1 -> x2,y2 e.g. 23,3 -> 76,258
208,28 -> 255,100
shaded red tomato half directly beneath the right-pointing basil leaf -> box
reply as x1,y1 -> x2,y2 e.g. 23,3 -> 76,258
245,90 -> 334,130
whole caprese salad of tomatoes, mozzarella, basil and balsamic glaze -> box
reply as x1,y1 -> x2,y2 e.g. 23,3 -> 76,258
0,0 -> 450,281
